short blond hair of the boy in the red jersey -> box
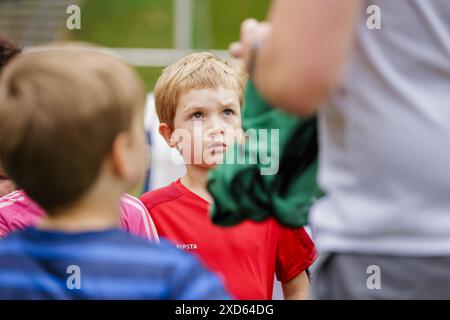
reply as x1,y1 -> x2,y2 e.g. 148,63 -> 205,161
155,52 -> 246,126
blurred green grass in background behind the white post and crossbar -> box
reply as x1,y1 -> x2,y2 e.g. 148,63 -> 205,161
68,0 -> 270,91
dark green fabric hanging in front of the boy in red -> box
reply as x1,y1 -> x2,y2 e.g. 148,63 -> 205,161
208,81 -> 322,226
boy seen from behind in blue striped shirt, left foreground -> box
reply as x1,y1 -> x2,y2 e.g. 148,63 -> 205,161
0,47 -> 227,299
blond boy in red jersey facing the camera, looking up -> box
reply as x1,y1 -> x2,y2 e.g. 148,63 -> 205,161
141,53 -> 315,299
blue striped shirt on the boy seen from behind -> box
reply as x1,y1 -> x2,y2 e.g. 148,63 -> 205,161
0,228 -> 229,299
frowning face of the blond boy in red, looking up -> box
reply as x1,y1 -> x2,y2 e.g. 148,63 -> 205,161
167,87 -> 242,168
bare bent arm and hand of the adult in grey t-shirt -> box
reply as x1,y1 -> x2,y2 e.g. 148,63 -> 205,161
230,0 -> 361,116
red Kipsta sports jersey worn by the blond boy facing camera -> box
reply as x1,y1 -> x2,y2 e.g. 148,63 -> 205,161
140,180 -> 315,299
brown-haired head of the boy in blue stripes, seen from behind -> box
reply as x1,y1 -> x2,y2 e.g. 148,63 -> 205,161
0,46 -> 147,214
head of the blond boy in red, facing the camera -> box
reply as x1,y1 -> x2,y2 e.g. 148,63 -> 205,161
155,52 -> 246,168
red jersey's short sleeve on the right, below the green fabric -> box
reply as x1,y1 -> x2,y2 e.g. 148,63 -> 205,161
275,226 -> 316,283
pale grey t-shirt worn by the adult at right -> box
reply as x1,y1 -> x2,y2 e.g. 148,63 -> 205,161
311,0 -> 450,256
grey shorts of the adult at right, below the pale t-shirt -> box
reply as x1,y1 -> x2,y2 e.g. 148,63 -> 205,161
311,253 -> 450,300
